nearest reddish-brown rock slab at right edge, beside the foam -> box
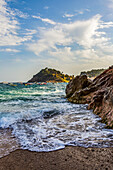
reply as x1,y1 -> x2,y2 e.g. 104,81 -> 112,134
88,86 -> 113,128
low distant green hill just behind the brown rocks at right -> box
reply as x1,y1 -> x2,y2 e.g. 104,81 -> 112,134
80,69 -> 105,78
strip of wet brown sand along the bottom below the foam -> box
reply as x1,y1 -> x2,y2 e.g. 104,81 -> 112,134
0,146 -> 113,170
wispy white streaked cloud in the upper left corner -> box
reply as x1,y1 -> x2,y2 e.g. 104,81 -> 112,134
0,0 -> 31,46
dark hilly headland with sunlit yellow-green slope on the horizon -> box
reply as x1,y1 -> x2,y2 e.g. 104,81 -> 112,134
28,67 -> 74,82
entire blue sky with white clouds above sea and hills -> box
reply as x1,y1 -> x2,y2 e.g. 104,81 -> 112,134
0,0 -> 113,81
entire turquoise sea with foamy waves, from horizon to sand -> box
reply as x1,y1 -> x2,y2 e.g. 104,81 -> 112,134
0,83 -> 113,157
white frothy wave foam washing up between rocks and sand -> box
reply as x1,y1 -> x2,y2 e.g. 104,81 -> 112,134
9,109 -> 113,151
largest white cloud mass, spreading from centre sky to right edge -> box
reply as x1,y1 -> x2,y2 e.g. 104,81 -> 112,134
28,15 -> 113,66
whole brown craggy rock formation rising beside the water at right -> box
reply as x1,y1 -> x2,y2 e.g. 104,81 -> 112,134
66,66 -> 113,128
